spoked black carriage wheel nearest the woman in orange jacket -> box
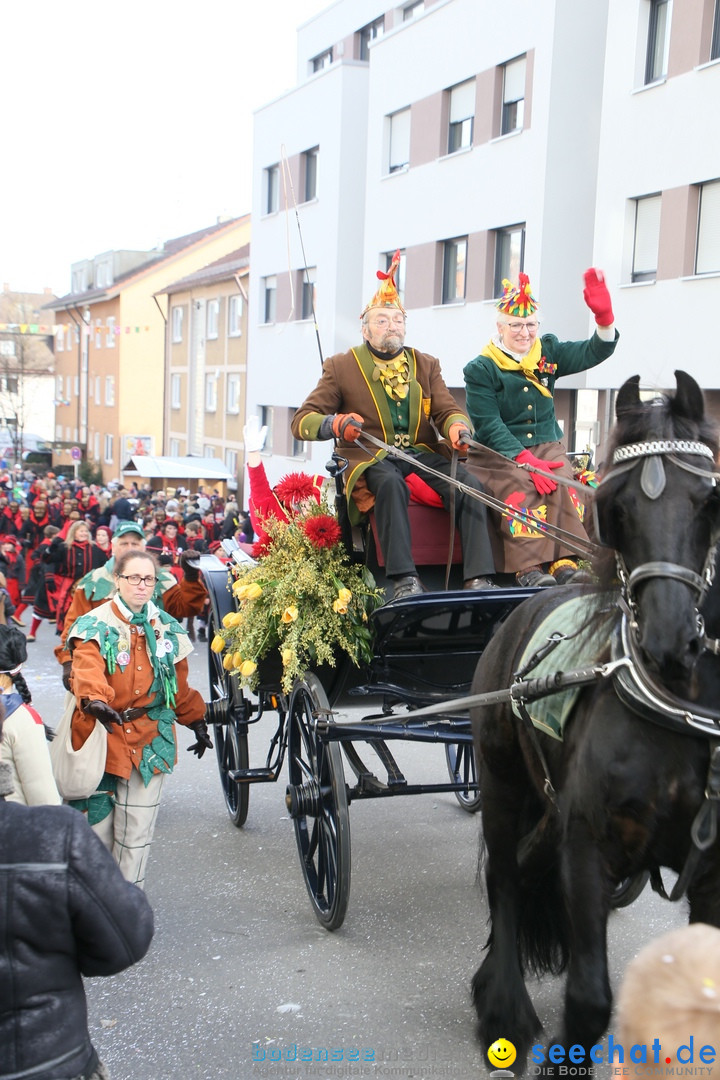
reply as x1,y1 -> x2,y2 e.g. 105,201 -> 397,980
207,611 -> 250,828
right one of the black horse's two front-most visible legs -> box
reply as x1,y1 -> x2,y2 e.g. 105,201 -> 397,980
559,818 -> 612,1054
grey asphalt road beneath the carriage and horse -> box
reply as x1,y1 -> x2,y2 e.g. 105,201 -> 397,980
25,624 -> 685,1080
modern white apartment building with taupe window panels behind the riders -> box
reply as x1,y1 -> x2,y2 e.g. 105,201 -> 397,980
247,0 -> 720,481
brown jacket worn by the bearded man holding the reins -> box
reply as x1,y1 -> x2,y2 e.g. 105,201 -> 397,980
291,345 -> 470,518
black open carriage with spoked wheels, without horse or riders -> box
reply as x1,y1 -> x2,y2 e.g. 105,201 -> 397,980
201,535 -> 536,930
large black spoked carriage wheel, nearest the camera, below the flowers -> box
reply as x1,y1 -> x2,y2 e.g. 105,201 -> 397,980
286,674 -> 350,930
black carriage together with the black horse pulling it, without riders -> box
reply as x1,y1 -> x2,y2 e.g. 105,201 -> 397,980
198,373 -> 720,1067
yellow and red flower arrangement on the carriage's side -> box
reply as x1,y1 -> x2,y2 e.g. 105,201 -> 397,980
210,501 -> 382,692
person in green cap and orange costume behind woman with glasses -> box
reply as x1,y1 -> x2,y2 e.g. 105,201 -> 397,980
55,522 -> 207,690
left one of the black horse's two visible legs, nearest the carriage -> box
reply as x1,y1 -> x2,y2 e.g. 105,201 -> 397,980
472,768 -> 542,1071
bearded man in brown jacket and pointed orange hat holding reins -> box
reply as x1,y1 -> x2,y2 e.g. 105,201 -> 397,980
291,252 -> 494,599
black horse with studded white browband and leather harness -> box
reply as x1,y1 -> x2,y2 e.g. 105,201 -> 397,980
472,372 -> 720,1068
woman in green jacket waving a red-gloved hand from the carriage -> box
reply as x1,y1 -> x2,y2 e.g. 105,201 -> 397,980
464,269 -> 619,588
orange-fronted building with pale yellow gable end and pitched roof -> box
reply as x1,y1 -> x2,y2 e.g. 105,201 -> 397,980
49,217 -> 249,483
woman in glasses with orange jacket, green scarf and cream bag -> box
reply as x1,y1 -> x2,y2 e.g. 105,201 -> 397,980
67,549 -> 213,887
